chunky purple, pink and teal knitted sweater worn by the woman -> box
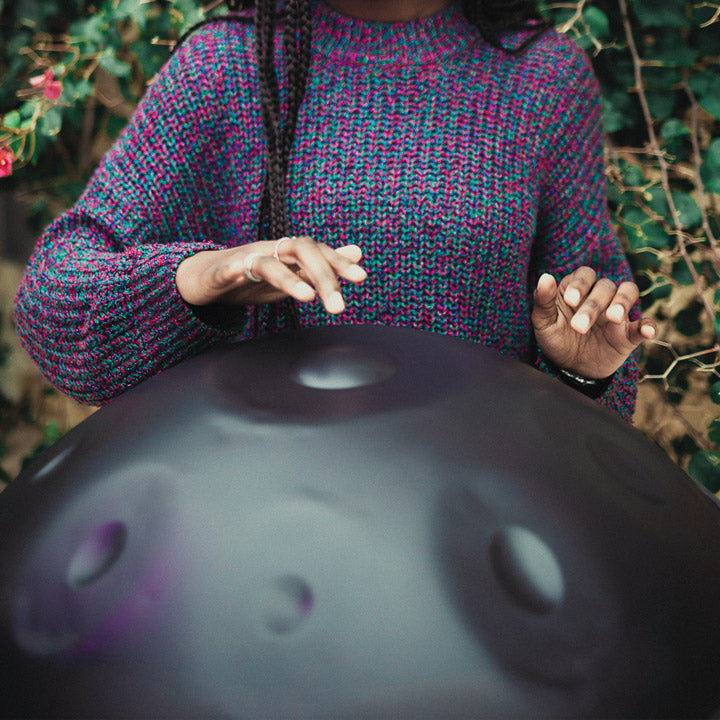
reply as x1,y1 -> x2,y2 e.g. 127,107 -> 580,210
15,0 -> 636,419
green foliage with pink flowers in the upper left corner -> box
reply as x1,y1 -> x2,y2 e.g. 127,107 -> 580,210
0,0 -> 212,232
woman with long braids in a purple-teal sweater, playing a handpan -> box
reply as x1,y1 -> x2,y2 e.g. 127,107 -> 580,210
16,0 -> 655,419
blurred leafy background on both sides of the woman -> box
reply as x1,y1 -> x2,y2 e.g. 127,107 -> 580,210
0,0 -> 720,492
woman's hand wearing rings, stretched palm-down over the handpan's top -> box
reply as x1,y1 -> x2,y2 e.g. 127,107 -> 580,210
175,237 -> 367,315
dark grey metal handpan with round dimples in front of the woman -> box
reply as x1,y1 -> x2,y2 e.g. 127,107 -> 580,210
0,326 -> 720,720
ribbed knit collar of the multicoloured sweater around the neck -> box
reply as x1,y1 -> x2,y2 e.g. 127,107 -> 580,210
312,0 -> 477,67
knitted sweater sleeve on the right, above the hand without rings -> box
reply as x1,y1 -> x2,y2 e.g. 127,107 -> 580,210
530,36 -> 638,421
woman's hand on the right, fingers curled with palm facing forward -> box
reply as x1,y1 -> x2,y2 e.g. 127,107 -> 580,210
532,267 -> 657,378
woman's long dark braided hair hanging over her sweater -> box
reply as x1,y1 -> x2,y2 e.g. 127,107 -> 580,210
173,0 -> 550,329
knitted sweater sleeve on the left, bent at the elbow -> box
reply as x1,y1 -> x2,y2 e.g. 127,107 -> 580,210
15,26 -> 250,404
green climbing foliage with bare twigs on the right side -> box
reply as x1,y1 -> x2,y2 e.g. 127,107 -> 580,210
543,0 -> 720,492
